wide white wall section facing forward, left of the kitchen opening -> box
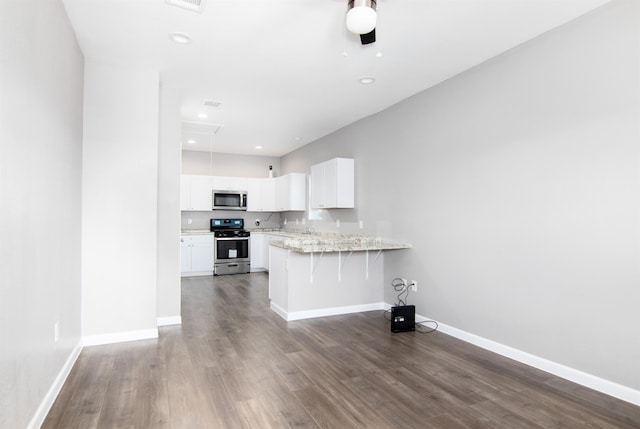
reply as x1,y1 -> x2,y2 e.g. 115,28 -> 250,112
82,59 -> 160,344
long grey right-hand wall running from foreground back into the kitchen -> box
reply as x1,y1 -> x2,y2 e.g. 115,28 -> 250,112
281,1 -> 640,400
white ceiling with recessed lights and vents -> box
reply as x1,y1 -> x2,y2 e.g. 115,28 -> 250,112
63,0 -> 609,156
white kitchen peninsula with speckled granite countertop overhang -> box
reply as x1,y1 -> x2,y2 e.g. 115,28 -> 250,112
269,233 -> 411,320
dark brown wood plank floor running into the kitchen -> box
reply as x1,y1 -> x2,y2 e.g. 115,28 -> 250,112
43,273 -> 640,429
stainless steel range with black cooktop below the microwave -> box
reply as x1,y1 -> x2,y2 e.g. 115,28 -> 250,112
211,219 -> 251,276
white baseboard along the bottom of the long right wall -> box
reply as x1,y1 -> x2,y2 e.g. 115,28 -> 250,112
385,303 -> 640,405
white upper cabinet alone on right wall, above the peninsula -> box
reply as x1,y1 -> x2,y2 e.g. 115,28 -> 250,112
311,158 -> 355,209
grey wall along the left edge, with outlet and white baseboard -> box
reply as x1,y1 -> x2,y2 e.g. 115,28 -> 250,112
0,0 -> 83,428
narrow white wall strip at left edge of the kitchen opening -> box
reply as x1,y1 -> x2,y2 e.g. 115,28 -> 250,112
157,87 -> 181,325
